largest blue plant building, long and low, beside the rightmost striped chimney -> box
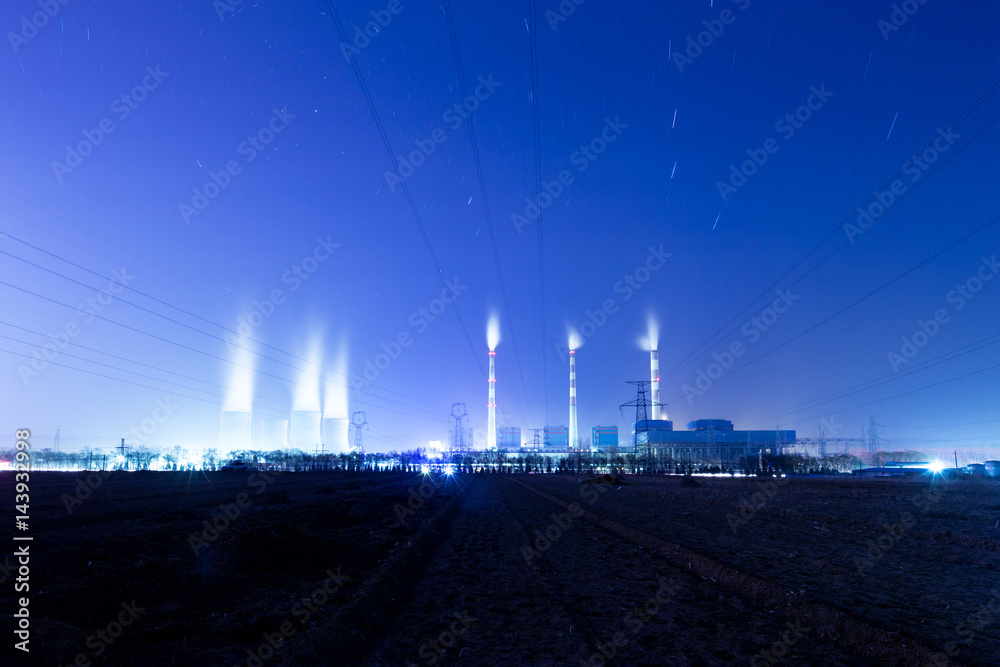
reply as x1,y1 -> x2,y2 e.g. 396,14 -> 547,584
632,419 -> 795,466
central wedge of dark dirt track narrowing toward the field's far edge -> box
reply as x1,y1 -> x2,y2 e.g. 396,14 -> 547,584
362,475 -> 587,667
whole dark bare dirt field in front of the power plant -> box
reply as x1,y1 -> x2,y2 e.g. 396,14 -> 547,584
0,472 -> 1000,666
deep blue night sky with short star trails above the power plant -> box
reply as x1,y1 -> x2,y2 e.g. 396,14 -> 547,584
0,0 -> 1000,458
